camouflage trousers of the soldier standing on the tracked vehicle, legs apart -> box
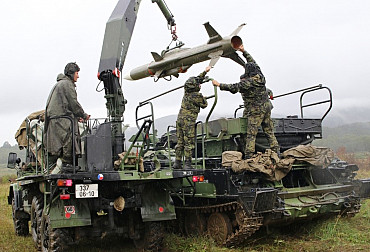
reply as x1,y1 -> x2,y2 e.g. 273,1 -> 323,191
243,102 -> 280,158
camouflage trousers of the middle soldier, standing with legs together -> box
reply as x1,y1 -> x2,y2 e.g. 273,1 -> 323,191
175,116 -> 195,160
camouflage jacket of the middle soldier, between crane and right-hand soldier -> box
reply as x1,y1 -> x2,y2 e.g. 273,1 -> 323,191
178,72 -> 208,121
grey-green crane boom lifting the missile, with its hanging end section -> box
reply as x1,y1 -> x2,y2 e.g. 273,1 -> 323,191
98,0 -> 175,157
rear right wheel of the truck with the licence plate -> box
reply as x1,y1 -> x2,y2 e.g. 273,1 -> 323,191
134,222 -> 164,251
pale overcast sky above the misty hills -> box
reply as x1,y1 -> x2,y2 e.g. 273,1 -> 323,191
0,0 -> 370,145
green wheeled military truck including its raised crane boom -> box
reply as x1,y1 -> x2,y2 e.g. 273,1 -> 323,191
8,0 -> 202,251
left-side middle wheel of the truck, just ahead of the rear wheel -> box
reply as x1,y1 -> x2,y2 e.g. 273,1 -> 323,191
31,196 -> 44,250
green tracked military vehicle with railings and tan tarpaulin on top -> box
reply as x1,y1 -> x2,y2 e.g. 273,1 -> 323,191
150,84 -> 370,246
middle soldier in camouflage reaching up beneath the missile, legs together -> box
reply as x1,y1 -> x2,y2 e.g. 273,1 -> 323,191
173,66 -> 211,169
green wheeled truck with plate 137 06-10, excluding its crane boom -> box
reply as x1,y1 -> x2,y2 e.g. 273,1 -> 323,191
8,113 -> 202,251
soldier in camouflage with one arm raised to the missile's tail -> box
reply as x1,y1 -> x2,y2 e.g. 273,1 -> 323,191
212,45 -> 280,159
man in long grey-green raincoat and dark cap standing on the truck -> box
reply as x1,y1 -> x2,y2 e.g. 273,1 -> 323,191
45,63 -> 90,166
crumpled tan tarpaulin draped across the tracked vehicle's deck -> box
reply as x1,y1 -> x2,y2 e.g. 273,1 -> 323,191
222,145 -> 334,181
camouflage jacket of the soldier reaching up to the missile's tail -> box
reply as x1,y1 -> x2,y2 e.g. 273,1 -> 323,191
220,51 -> 268,110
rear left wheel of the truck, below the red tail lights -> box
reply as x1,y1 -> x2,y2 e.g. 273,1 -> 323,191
40,215 -> 72,252
